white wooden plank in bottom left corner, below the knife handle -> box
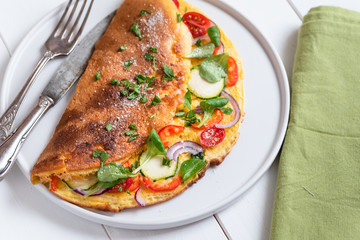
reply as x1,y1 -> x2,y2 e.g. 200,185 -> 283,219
0,163 -> 109,240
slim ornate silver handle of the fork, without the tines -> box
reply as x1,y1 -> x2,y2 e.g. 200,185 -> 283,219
0,51 -> 54,145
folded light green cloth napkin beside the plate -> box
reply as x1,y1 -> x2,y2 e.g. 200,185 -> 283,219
271,6 -> 360,240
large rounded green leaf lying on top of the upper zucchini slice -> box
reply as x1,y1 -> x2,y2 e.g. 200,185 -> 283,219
200,53 -> 229,83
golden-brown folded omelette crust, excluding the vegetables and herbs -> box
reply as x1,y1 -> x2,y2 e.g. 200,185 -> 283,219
31,0 -> 244,212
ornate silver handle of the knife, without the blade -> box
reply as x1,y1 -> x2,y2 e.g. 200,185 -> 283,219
0,95 -> 54,181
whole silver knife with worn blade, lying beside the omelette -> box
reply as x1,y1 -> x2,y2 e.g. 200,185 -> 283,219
0,12 -> 115,181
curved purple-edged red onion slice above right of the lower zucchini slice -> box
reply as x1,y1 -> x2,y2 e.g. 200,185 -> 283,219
166,141 -> 204,161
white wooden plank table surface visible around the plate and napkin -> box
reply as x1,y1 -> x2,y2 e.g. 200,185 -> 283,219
0,0 -> 360,240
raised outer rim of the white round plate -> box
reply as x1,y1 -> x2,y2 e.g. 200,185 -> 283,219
0,0 -> 290,230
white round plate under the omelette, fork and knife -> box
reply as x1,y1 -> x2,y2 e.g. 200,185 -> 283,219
0,0 -> 290,229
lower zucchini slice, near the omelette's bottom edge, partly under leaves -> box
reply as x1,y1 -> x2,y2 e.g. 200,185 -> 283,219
139,151 -> 179,180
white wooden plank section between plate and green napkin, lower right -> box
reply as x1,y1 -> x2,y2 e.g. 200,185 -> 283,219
216,158 -> 278,240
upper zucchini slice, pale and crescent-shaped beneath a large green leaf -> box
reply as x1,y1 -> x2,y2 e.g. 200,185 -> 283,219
187,69 -> 225,99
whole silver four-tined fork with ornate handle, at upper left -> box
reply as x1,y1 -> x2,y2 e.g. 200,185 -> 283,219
0,0 -> 94,145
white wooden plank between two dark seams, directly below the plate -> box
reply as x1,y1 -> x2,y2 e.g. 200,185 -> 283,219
105,217 -> 227,240
